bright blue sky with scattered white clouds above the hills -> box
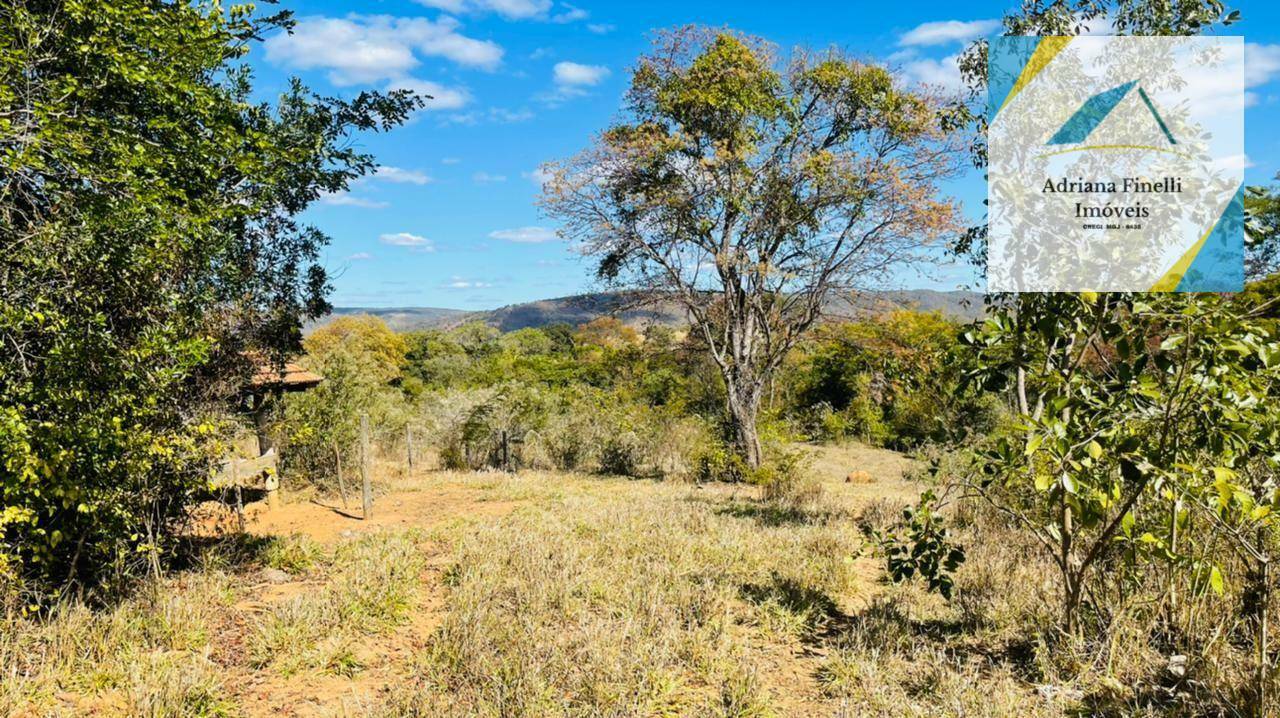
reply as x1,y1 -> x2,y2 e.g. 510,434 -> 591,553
250,0 -> 1280,310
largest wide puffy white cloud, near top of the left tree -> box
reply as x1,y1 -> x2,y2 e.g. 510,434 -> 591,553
265,14 -> 503,86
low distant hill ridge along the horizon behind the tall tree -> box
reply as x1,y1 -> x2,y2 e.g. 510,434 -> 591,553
307,289 -> 982,331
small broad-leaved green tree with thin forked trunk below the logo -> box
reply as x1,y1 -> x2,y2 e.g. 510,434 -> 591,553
966,293 -> 1280,632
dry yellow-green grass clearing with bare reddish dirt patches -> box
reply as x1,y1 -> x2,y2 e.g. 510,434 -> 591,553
0,447 -> 1071,717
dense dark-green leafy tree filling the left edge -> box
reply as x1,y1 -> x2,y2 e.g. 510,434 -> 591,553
0,0 -> 421,595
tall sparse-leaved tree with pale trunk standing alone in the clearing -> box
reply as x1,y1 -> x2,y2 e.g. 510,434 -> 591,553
543,27 -> 963,468
